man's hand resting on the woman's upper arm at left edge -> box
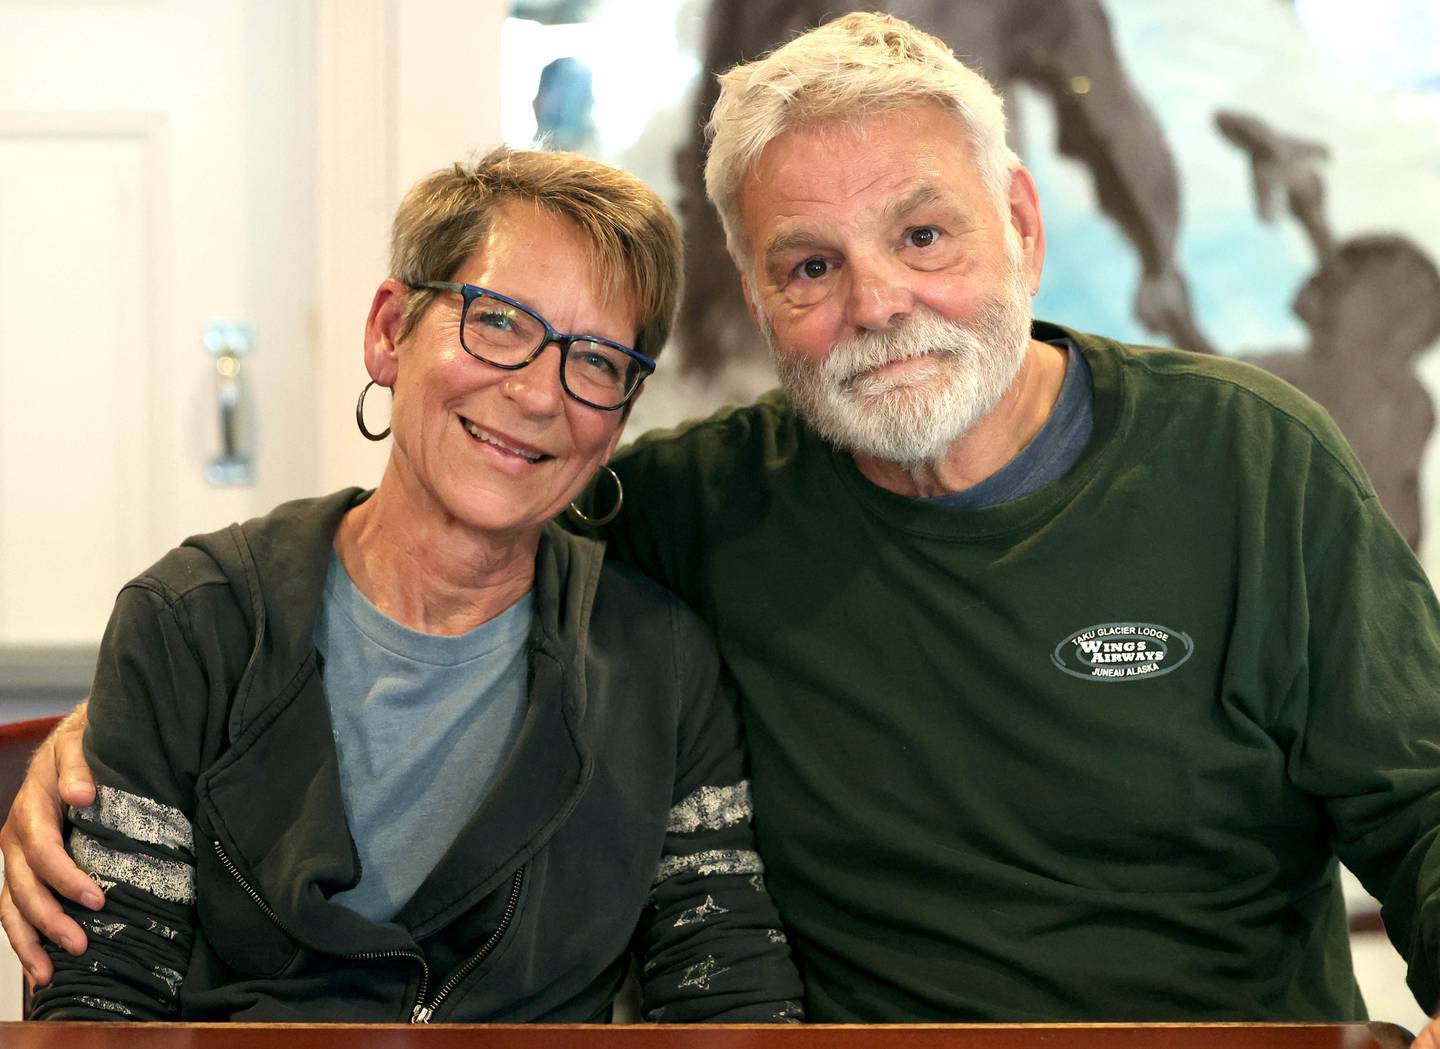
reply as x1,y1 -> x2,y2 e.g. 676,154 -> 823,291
0,703 -> 105,986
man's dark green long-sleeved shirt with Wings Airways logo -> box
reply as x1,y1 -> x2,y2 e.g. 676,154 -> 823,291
590,326 -> 1440,1022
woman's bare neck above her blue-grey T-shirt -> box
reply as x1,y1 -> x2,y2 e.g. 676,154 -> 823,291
336,460 -> 540,635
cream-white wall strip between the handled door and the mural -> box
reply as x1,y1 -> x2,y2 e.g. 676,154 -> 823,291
315,0 -> 507,491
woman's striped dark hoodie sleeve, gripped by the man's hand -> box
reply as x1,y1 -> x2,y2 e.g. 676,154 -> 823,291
32,584 -> 224,1020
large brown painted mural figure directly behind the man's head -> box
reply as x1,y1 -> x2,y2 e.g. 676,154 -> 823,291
680,0 -> 1211,373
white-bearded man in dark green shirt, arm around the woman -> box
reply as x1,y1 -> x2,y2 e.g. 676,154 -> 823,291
4,14 -> 1440,1043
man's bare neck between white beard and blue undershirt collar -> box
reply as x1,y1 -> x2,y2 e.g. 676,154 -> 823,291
852,339 -> 1066,499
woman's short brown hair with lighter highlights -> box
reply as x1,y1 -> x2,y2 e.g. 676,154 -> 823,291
390,146 -> 683,357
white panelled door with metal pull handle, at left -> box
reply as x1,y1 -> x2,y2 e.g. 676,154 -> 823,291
0,0 -> 317,657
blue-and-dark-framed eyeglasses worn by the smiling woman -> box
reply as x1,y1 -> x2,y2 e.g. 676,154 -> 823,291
410,281 -> 655,412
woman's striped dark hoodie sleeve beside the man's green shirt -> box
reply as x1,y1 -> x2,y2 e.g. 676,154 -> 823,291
636,602 -> 804,1023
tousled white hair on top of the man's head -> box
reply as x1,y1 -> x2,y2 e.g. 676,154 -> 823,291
706,12 -> 1020,259
